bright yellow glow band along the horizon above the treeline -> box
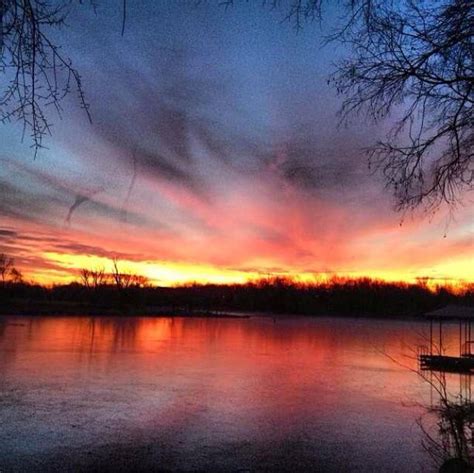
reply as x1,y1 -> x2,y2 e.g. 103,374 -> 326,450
19,252 -> 474,287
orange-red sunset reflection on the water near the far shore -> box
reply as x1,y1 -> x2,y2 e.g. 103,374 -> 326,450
0,317 -> 430,394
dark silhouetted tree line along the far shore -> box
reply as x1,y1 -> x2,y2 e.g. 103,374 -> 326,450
0,255 -> 474,317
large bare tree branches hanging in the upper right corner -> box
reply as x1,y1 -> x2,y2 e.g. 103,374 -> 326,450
334,0 -> 474,210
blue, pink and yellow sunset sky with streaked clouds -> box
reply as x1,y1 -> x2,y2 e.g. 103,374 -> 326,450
0,0 -> 474,285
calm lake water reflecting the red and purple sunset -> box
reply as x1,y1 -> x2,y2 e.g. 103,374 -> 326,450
0,317 -> 460,472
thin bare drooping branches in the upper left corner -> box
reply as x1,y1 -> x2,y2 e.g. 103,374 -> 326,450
0,0 -> 91,156
